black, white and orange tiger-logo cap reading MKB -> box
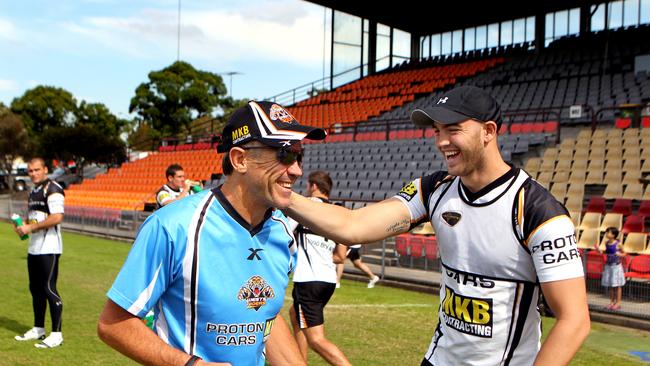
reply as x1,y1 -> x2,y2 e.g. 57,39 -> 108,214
217,101 -> 327,152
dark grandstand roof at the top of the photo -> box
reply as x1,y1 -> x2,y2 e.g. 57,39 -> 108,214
307,0 -> 604,35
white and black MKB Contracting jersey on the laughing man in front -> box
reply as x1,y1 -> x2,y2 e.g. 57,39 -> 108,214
396,168 -> 583,366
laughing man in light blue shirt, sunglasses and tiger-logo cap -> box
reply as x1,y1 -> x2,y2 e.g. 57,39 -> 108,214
98,101 -> 325,366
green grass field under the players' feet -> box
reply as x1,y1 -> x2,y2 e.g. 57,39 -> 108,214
0,223 -> 650,366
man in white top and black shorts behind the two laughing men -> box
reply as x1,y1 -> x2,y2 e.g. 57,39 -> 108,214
290,170 -> 350,365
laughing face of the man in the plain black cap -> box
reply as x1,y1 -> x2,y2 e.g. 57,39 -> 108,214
434,119 -> 485,177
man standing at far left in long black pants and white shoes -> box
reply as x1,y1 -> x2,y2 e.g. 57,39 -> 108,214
14,158 -> 65,348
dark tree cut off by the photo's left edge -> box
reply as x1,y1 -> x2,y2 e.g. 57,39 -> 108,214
0,105 -> 31,187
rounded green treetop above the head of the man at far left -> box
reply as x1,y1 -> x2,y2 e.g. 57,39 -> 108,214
11,85 -> 77,136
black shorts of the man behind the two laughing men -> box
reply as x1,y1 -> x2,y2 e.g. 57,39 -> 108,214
291,281 -> 336,329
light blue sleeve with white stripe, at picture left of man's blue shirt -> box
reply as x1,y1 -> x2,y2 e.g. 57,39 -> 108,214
107,215 -> 175,317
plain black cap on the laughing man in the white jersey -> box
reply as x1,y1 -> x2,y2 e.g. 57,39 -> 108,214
411,86 -> 503,129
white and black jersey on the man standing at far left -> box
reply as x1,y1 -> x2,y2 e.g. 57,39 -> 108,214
27,179 -> 65,254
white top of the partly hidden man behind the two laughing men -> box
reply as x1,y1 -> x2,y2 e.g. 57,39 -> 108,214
289,197 -> 336,283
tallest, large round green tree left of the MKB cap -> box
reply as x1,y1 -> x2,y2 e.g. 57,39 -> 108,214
129,61 -> 227,135
